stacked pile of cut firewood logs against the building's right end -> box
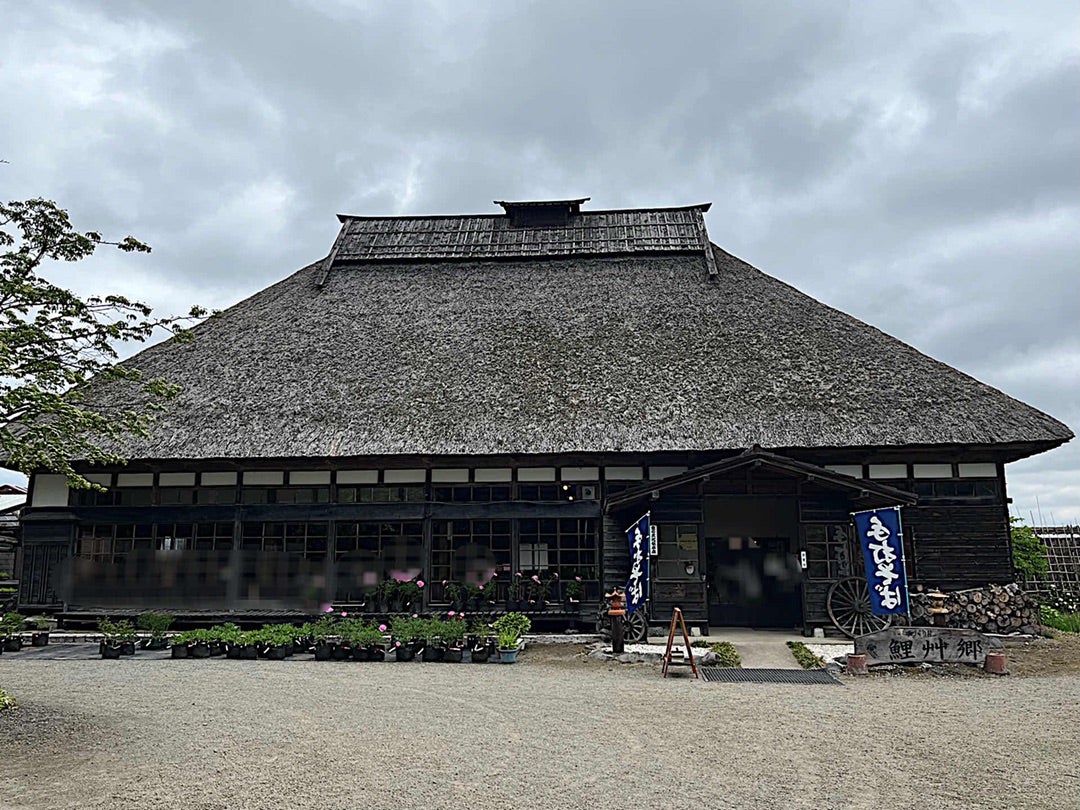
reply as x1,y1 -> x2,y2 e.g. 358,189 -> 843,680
912,583 -> 1039,633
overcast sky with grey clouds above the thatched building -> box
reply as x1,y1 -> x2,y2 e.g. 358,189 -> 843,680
0,0 -> 1080,523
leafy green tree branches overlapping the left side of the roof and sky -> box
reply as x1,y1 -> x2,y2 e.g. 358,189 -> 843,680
0,199 -> 206,488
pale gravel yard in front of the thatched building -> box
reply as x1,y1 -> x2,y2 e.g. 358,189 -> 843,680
0,646 -> 1080,810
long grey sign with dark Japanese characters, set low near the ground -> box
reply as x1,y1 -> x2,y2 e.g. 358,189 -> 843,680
855,627 -> 1002,666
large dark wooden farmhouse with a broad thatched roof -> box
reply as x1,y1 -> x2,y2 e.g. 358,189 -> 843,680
22,199 -> 1072,632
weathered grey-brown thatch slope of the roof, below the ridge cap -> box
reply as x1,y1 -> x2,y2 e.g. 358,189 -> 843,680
78,208 -> 1072,459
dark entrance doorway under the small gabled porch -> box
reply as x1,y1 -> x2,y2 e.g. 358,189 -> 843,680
705,537 -> 802,627
